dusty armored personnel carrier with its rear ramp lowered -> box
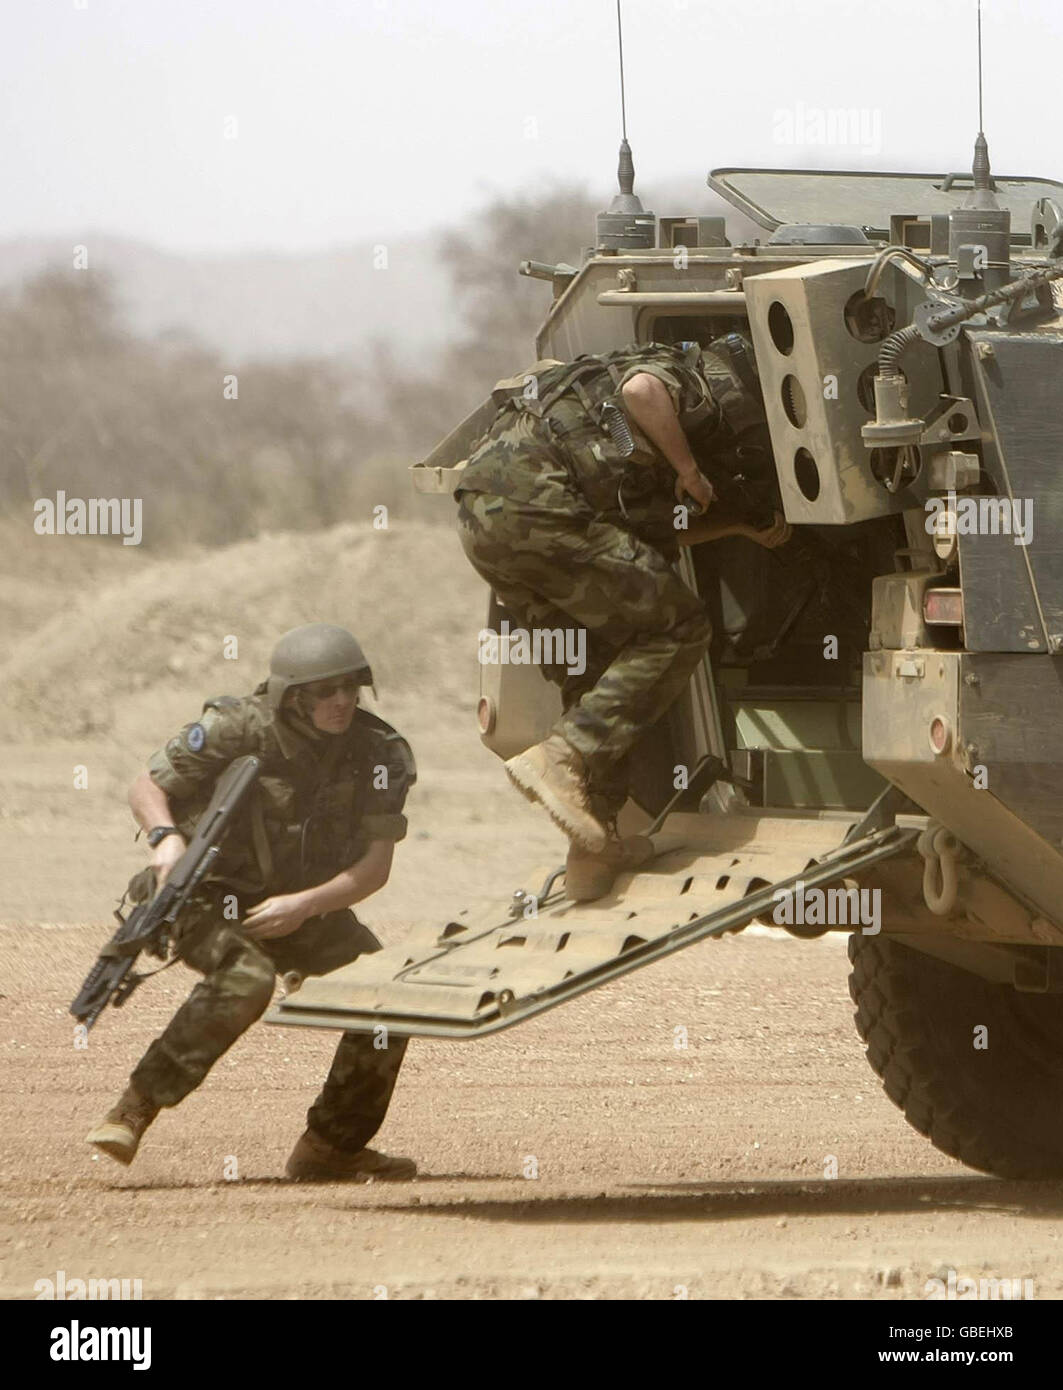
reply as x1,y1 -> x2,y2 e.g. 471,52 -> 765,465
272,135 -> 1063,1177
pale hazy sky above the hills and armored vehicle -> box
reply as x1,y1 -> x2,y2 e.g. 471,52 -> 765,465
0,0 -> 1063,252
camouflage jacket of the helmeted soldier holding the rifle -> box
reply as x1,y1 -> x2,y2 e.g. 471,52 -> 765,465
147,687 -> 417,892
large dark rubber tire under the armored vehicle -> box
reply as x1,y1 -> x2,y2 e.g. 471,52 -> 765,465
849,934 -> 1063,1179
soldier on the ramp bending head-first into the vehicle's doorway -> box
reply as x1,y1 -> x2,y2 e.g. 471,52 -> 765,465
456,334 -> 791,901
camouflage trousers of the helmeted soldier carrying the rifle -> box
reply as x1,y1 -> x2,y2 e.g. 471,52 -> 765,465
131,898 -> 407,1152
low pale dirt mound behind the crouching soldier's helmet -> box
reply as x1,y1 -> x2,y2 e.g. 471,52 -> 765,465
0,521 -> 485,741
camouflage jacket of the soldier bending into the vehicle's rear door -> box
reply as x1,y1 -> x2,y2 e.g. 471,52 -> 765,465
456,343 -> 721,542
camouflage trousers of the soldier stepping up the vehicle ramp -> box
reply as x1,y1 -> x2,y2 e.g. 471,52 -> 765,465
459,492 -> 711,820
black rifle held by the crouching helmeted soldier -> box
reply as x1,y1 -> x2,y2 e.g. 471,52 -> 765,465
69,756 -> 261,1029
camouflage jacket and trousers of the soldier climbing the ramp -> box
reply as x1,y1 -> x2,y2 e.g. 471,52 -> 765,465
456,343 -> 720,820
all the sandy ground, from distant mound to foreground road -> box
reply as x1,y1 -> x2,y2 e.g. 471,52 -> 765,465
0,528 -> 1063,1300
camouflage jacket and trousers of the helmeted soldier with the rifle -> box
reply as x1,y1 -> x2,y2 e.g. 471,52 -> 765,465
131,687 -> 415,1152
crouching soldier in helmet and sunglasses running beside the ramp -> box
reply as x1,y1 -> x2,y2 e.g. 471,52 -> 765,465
88,623 -> 417,1180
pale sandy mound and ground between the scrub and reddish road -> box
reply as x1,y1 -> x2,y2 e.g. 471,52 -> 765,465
0,517 -> 564,940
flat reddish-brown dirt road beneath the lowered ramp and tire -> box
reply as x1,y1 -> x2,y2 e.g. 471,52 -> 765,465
0,913 -> 1063,1298
